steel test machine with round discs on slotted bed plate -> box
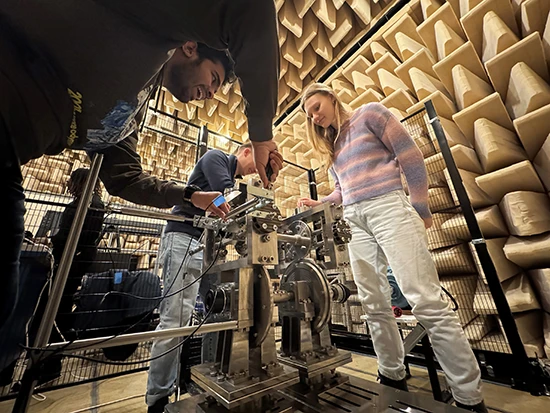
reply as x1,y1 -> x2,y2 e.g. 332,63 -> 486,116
165,180 -> 470,413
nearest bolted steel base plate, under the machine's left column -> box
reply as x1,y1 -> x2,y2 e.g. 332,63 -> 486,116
191,363 -> 299,409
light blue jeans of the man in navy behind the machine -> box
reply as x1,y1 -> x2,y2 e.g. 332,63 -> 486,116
146,232 -> 202,406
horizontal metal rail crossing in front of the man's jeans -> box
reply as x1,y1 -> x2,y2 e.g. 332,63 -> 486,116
48,321 -> 238,351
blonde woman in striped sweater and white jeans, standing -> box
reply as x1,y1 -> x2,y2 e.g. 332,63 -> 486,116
298,83 -> 487,412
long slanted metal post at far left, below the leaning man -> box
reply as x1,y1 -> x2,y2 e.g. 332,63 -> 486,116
12,153 -> 103,413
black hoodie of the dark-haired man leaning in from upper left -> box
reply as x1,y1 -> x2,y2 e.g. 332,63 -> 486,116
0,0 -> 279,207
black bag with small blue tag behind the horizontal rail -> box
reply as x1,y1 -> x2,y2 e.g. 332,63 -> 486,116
74,270 -> 162,361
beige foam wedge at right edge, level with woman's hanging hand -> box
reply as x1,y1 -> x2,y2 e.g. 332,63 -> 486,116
500,191 -> 550,237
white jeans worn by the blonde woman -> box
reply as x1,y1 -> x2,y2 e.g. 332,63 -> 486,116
344,191 -> 483,405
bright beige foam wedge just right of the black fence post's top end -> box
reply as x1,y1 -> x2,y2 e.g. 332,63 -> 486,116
452,65 -> 494,110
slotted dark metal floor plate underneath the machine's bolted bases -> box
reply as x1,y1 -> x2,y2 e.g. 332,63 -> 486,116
165,376 -> 466,413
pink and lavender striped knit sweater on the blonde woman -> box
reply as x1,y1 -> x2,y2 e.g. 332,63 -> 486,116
322,103 -> 431,218
